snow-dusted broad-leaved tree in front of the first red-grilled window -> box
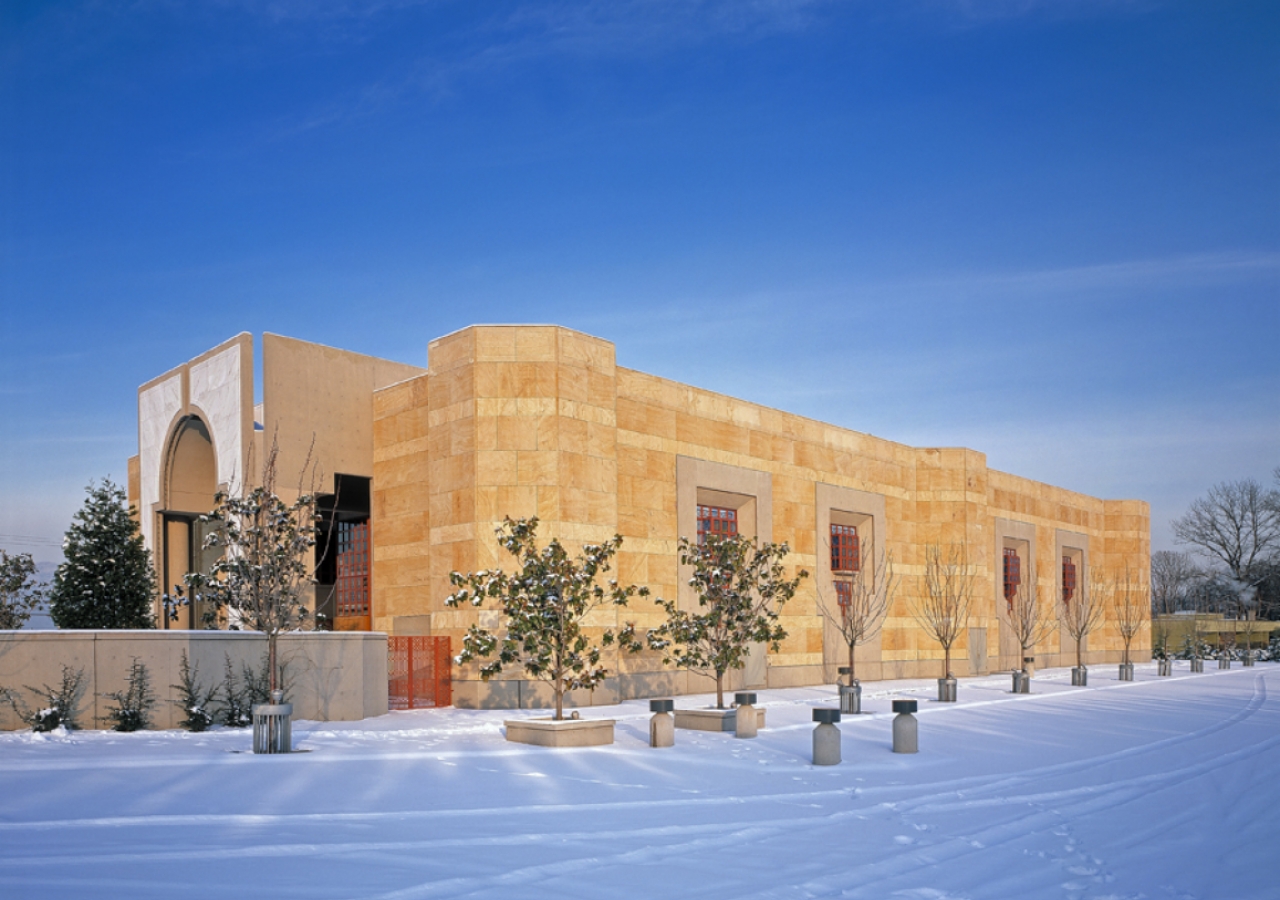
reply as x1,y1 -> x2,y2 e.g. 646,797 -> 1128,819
648,535 -> 809,709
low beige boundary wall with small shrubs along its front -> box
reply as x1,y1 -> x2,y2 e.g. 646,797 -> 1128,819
0,630 -> 387,731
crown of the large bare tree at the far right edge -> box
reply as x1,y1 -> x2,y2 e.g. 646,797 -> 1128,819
1172,479 -> 1280,584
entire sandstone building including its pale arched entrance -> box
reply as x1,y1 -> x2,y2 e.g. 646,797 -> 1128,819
129,325 -> 1151,707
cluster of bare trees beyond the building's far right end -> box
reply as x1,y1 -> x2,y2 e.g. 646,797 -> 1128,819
1151,467 -> 1280,620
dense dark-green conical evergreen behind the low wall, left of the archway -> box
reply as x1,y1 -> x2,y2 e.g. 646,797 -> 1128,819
49,479 -> 156,629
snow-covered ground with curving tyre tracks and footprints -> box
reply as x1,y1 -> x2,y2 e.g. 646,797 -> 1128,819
0,663 -> 1280,900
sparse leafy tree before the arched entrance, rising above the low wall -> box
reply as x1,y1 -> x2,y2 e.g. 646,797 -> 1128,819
186,439 -> 319,690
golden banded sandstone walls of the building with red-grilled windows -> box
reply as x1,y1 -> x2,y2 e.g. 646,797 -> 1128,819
131,325 -> 1149,707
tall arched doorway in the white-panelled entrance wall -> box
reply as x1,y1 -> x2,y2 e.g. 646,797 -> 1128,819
156,416 -> 218,629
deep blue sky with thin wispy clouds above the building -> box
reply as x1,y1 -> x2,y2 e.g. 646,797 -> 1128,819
0,0 -> 1280,557
